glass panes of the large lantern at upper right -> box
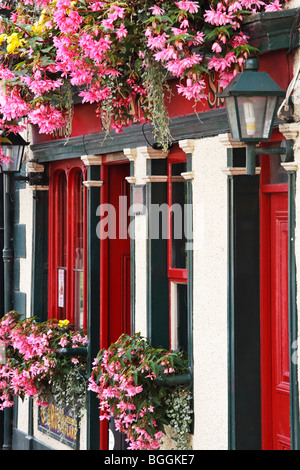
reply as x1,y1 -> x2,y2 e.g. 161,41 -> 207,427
237,96 -> 277,141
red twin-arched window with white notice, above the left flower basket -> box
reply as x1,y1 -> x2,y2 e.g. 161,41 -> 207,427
48,160 -> 86,328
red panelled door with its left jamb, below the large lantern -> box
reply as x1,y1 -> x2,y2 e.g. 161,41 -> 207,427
261,162 -> 290,450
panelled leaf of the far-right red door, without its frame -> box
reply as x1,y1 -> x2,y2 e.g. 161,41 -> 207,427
270,193 -> 290,450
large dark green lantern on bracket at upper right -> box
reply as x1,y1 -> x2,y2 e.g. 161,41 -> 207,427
219,59 -> 292,175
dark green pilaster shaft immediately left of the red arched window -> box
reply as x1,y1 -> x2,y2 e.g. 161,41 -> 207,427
31,191 -> 49,321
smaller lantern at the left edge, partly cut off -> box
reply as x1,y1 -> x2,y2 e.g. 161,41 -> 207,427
1,133 -> 28,173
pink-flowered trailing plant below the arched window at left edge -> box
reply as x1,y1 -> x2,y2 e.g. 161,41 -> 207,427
0,311 -> 87,412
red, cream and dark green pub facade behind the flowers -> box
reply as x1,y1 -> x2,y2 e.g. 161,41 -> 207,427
2,1 -> 300,450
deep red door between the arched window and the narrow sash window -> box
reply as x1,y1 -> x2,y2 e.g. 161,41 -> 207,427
100,162 -> 131,450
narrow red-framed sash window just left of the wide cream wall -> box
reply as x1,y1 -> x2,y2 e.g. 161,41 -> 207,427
168,151 -> 187,351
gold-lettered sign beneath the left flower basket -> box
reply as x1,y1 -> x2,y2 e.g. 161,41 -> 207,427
38,403 -> 79,449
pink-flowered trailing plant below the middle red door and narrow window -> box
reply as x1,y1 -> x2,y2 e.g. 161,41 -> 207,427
89,333 -> 190,450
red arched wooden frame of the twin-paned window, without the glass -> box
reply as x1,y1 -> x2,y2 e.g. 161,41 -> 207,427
48,159 -> 87,329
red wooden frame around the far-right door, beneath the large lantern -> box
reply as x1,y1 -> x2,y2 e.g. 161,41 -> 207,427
260,152 -> 288,450
